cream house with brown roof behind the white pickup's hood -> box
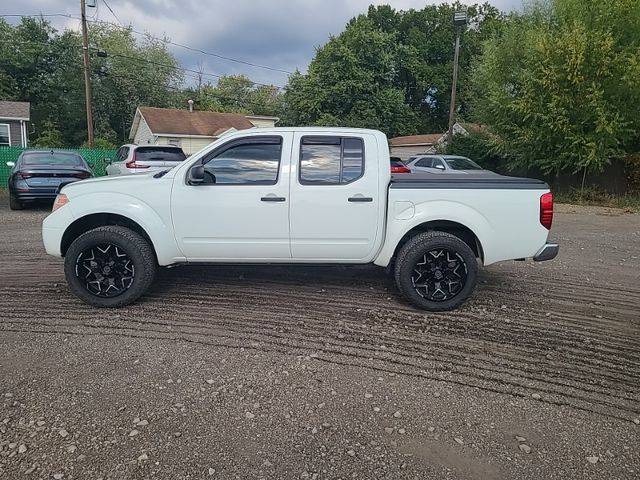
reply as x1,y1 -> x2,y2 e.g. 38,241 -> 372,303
129,107 -> 279,155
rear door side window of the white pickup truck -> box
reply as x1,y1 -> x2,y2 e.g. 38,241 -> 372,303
299,136 -> 364,185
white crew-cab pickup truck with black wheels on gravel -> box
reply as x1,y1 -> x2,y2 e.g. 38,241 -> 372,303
42,128 -> 558,311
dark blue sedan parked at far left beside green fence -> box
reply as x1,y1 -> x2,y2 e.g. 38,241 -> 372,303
7,150 -> 92,210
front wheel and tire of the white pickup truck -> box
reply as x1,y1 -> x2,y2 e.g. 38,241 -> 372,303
64,225 -> 157,308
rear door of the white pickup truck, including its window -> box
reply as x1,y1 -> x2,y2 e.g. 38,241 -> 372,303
289,133 -> 380,263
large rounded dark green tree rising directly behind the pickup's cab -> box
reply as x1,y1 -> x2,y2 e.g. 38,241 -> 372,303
284,15 -> 417,135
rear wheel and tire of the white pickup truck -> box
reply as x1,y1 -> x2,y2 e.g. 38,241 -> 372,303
395,231 -> 478,312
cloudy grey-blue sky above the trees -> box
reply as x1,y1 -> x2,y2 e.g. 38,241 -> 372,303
0,0 -> 522,86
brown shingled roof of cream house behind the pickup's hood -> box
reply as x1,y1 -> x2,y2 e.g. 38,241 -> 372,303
138,107 -> 253,137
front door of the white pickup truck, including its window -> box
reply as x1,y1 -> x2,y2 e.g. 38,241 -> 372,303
171,132 -> 293,262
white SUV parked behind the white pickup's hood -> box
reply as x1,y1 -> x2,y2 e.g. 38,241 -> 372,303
106,145 -> 187,175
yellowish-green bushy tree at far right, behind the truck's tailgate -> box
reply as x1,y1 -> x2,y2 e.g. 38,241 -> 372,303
473,0 -> 640,173
